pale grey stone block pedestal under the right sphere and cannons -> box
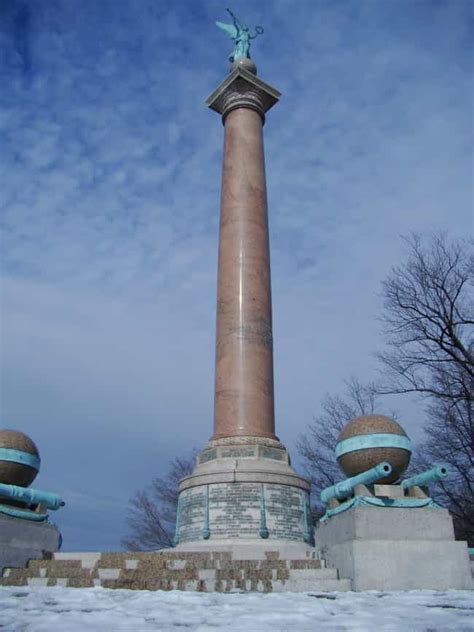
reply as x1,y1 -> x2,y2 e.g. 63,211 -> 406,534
315,507 -> 473,591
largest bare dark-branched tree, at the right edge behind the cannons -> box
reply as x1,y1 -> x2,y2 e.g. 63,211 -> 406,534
377,234 -> 474,545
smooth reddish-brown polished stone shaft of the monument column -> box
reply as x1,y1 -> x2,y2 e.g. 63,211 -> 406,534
213,107 -> 275,439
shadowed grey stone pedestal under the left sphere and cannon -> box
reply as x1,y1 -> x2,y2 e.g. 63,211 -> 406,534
0,514 -> 61,575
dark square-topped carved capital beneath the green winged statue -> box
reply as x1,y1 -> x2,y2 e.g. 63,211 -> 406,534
206,66 -> 281,122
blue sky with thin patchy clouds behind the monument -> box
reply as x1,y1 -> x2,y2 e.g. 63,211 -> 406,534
0,0 -> 473,550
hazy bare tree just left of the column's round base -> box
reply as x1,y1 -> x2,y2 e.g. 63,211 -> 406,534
122,450 -> 197,551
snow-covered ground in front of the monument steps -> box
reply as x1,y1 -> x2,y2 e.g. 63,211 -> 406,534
0,587 -> 474,632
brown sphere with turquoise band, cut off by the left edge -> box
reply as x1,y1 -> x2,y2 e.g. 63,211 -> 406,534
0,430 -> 40,487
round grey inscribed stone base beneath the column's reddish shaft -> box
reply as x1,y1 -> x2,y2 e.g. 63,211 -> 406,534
176,437 -> 312,549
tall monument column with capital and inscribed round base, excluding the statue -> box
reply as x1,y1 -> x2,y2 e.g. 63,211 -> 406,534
176,60 -> 312,550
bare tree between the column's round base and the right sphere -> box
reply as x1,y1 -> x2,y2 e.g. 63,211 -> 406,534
296,378 -> 386,516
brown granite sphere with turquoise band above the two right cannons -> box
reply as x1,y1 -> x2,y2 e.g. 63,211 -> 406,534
336,415 -> 411,484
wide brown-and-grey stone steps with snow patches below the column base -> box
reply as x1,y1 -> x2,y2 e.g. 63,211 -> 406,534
0,550 -> 351,592
